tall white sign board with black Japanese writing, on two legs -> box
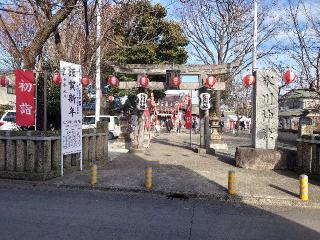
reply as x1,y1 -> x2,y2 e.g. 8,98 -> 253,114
60,61 -> 82,174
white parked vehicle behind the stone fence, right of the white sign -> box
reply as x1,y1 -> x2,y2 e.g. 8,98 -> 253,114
82,115 -> 120,139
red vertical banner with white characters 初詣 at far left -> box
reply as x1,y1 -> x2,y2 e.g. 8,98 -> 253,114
16,69 -> 35,127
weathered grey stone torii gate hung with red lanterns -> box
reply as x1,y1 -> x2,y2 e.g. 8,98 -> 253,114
110,63 -> 238,151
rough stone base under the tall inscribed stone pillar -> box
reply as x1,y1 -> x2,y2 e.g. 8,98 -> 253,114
235,147 -> 287,170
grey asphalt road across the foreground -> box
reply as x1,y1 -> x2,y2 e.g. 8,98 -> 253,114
0,185 -> 320,240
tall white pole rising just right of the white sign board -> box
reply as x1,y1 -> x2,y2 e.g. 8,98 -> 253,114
95,0 -> 102,126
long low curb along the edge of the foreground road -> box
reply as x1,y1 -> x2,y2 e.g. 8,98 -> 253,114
0,180 -> 320,209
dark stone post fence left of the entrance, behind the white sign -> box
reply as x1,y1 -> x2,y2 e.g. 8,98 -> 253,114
0,125 -> 108,180
